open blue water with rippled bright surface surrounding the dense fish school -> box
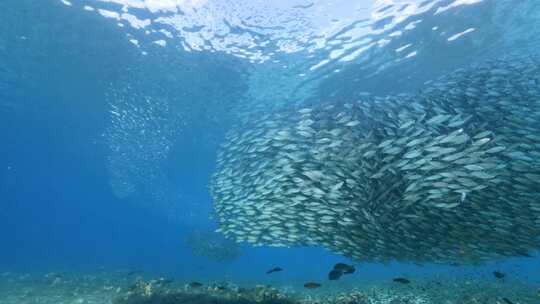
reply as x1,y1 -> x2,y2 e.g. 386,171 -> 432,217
0,0 -> 540,300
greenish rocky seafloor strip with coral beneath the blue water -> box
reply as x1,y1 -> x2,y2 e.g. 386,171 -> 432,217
0,272 -> 540,304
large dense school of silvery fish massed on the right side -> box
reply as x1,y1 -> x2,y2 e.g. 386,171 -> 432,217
210,58 -> 540,264
